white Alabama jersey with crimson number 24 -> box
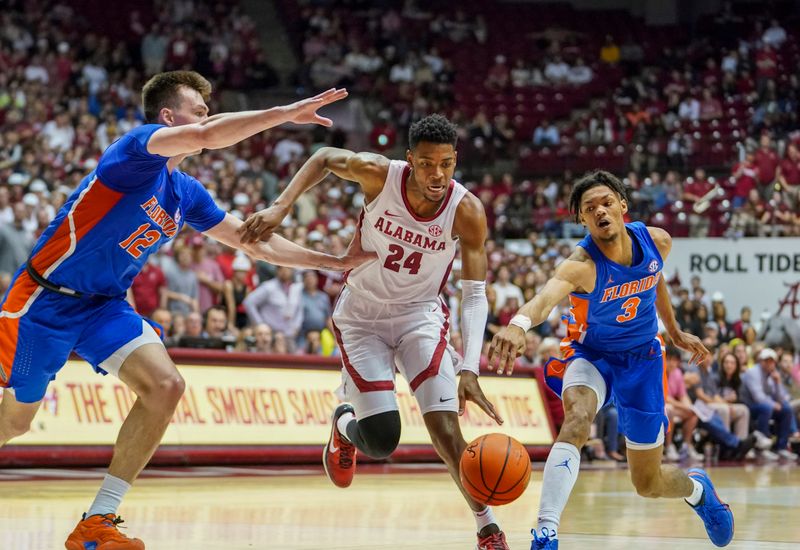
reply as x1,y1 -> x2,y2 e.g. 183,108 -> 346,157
347,160 -> 467,304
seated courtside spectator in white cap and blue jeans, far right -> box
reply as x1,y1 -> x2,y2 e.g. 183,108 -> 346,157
741,348 -> 797,460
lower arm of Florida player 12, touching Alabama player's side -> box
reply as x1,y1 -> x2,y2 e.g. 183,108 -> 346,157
205,214 -> 378,271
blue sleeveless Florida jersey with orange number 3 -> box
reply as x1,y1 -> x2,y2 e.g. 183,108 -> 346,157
567,222 -> 664,352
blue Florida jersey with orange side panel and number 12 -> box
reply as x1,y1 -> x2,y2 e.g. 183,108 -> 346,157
30,124 -> 225,296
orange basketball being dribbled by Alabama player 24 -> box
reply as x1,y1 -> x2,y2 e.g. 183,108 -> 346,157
459,434 -> 531,506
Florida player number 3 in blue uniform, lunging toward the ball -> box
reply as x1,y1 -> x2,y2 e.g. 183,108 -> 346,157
489,171 -> 733,550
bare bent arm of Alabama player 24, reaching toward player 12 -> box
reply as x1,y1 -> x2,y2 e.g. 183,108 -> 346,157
240,147 -> 389,243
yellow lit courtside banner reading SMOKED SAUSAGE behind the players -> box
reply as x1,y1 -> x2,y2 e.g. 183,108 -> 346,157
3,360 -> 553,446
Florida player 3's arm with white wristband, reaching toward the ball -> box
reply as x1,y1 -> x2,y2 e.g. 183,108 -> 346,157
489,248 -> 595,374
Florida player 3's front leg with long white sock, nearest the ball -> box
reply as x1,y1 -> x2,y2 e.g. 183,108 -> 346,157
531,357 -> 608,548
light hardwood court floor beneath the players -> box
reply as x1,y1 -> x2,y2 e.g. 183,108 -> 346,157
0,465 -> 800,550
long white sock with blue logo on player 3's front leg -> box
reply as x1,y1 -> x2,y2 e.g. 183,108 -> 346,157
538,442 -> 581,538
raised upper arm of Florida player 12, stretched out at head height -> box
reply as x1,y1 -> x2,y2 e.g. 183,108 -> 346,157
147,88 -> 347,157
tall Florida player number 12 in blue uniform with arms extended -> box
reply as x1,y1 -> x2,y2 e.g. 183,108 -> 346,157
0,71 -> 372,550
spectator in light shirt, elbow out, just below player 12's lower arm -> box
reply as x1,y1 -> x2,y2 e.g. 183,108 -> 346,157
244,267 -> 303,339
